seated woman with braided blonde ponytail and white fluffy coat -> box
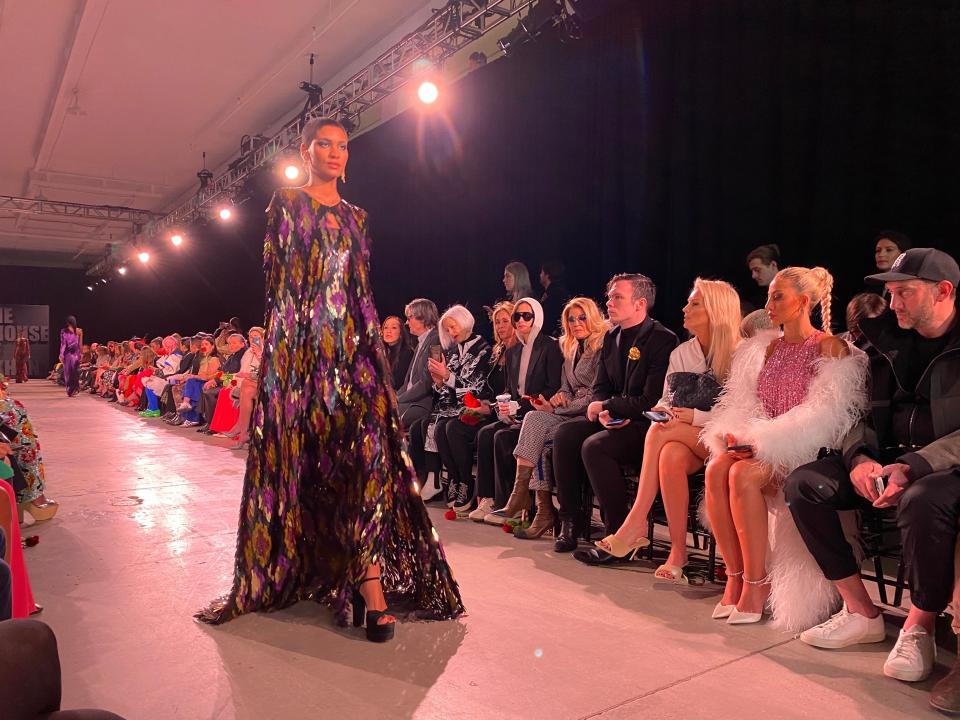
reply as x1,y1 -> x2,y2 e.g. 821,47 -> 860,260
700,267 -> 866,630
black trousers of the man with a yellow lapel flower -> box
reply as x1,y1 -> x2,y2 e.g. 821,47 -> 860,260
553,418 -> 648,534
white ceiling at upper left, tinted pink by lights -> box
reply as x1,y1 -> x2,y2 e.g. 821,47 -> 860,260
0,0 -> 442,267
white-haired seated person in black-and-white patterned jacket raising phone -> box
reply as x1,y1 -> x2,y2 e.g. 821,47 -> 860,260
410,305 -> 491,512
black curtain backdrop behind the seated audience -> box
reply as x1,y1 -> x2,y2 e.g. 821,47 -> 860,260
2,0 -> 960,354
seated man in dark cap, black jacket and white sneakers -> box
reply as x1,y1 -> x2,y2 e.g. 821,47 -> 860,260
786,248 -> 960,696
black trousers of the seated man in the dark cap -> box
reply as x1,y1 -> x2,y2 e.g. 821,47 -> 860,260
784,457 -> 960,612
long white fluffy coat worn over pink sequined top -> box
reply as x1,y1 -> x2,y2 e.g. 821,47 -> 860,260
700,331 -> 867,632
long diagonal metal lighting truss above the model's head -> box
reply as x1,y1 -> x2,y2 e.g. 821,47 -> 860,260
143,0 -> 537,242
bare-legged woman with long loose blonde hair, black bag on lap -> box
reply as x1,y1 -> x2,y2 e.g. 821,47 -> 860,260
596,278 -> 740,584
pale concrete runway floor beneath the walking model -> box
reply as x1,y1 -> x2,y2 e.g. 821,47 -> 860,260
7,380 -> 954,720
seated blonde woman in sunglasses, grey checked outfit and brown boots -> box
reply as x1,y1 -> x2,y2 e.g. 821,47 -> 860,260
506,297 -> 610,540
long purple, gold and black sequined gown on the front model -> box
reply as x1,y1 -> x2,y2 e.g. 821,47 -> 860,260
197,188 -> 463,624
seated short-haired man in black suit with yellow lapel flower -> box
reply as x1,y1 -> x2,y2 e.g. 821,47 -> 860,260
553,274 -> 677,560
